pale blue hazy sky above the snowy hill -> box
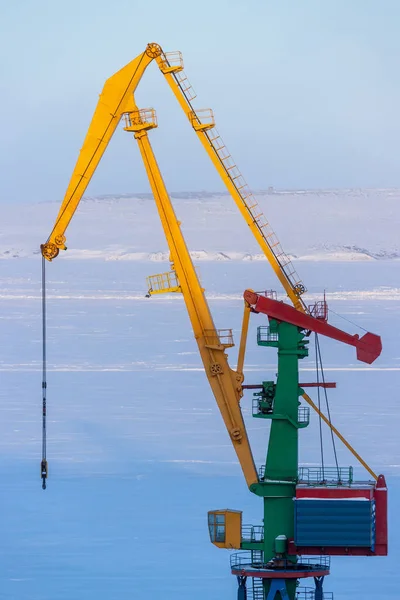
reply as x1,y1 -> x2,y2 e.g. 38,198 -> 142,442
0,0 -> 400,202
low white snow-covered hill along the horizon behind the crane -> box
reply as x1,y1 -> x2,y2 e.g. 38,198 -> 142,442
0,189 -> 400,261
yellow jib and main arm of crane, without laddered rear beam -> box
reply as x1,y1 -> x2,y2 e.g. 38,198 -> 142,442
41,44 -> 258,487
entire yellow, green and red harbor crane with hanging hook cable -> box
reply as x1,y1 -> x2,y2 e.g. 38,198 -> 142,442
41,43 -> 387,600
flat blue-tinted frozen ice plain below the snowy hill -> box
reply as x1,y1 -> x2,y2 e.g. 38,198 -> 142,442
0,260 -> 400,600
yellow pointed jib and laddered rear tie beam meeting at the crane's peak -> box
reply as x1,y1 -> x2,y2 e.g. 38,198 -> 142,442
41,43 -> 307,312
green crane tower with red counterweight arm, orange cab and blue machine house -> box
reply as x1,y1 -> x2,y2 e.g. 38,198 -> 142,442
208,298 -> 387,600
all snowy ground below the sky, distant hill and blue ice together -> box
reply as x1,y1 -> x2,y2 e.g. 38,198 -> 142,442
0,190 -> 400,600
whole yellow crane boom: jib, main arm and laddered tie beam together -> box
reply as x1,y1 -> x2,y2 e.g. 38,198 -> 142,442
41,43 -> 376,486
